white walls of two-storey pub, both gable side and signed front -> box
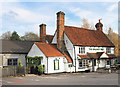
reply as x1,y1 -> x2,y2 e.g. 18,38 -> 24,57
64,33 -> 115,71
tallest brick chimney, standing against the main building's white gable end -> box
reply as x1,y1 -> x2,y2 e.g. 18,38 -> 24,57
57,11 -> 65,51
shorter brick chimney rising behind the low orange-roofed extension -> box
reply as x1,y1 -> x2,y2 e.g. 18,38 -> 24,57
39,24 -> 46,43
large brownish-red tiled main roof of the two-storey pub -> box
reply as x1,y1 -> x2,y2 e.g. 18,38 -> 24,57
65,26 -> 114,46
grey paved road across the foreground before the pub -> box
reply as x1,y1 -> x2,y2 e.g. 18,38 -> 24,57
2,73 -> 118,85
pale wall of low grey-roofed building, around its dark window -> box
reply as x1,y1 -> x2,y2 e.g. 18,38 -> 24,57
0,54 -> 26,67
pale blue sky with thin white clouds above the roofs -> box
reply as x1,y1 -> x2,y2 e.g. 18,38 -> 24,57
0,1 -> 118,36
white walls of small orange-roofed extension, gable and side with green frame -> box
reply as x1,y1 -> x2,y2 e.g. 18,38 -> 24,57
27,44 -> 67,74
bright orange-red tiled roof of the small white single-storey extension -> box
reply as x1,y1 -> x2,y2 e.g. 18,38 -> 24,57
35,42 -> 64,57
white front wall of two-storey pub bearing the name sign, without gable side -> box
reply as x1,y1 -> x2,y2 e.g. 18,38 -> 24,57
75,46 -> 115,71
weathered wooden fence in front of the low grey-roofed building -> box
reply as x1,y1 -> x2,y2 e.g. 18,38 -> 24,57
2,66 -> 26,77
